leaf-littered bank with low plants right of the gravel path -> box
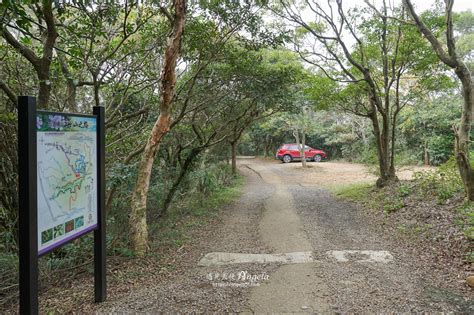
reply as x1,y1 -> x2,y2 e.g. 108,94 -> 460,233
333,158 -> 474,285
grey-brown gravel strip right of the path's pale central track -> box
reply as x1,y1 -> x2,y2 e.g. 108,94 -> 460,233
290,185 -> 474,313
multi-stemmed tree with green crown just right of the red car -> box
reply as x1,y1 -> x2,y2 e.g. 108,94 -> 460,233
272,0 -> 442,186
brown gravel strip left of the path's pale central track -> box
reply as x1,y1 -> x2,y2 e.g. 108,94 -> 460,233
94,163 -> 278,313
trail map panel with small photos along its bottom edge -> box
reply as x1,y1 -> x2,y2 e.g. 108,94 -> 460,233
36,112 -> 97,254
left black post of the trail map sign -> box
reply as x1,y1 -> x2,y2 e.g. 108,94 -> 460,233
18,96 -> 38,314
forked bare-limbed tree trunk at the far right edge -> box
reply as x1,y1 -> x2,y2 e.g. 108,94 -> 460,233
404,0 -> 474,200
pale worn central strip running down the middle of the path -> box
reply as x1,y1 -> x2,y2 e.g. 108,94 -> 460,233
246,162 -> 329,313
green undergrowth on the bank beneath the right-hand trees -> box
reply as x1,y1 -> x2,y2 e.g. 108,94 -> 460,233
333,158 -> 474,263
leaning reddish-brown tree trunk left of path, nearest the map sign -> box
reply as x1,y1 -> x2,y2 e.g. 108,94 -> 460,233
129,2 -> 286,255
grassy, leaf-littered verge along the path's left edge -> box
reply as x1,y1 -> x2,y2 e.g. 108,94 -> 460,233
0,164 -> 244,313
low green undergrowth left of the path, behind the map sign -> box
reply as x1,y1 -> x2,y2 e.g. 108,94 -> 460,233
0,163 -> 244,313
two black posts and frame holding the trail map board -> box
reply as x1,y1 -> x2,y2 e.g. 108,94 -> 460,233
18,96 -> 107,314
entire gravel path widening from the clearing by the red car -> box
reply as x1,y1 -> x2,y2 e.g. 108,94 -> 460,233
95,159 -> 474,313
